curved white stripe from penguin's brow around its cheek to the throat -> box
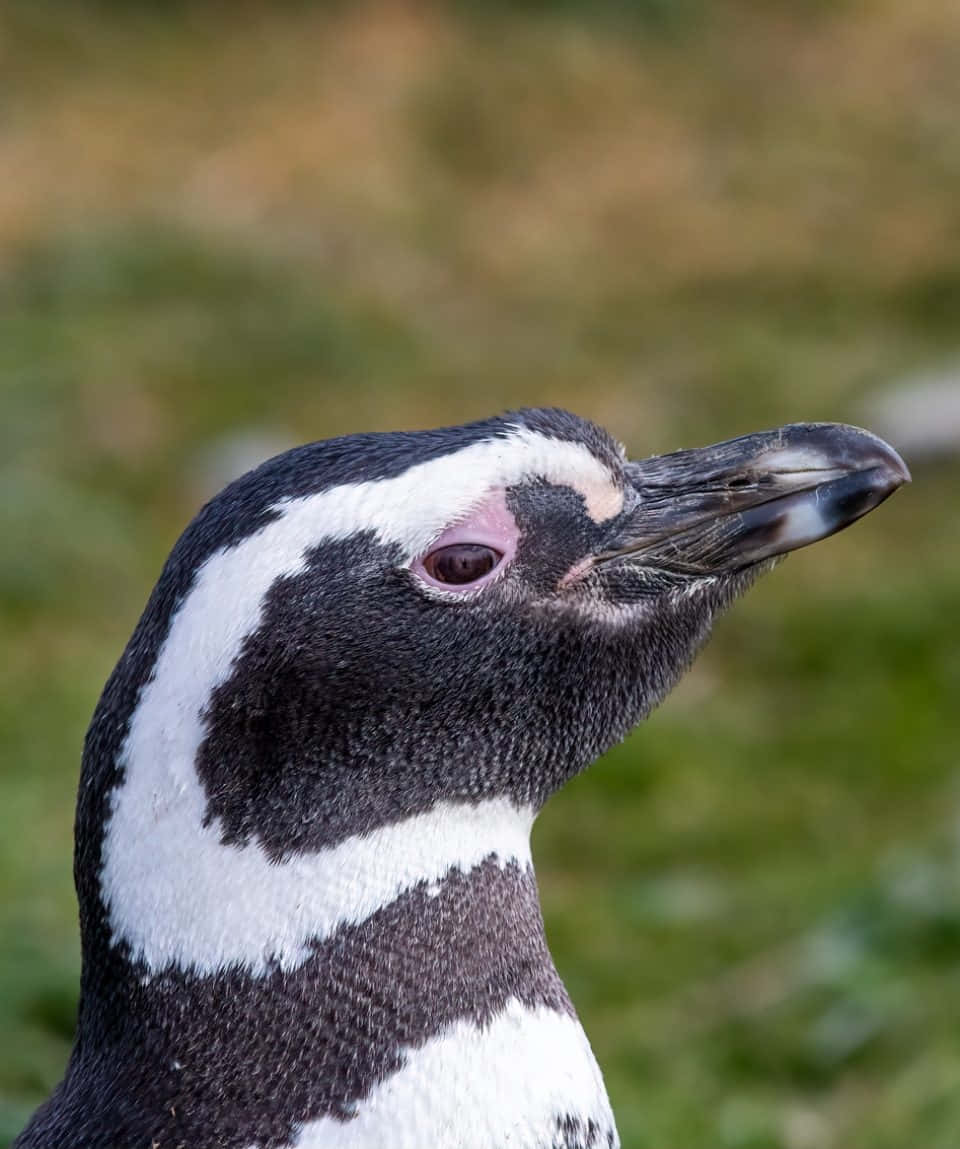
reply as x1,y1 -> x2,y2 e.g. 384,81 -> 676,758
101,429 -> 622,971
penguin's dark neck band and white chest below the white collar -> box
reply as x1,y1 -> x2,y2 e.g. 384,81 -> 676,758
57,820 -> 613,1149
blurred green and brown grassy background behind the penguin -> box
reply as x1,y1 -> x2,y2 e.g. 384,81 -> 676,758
0,0 -> 960,1149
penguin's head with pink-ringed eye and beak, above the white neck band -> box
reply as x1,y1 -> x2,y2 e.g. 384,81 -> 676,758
146,410 -> 907,858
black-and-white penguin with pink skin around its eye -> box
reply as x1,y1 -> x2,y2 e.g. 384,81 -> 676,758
16,410 -> 908,1149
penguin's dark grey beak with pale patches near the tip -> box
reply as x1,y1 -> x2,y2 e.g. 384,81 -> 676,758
596,423 -> 909,575
